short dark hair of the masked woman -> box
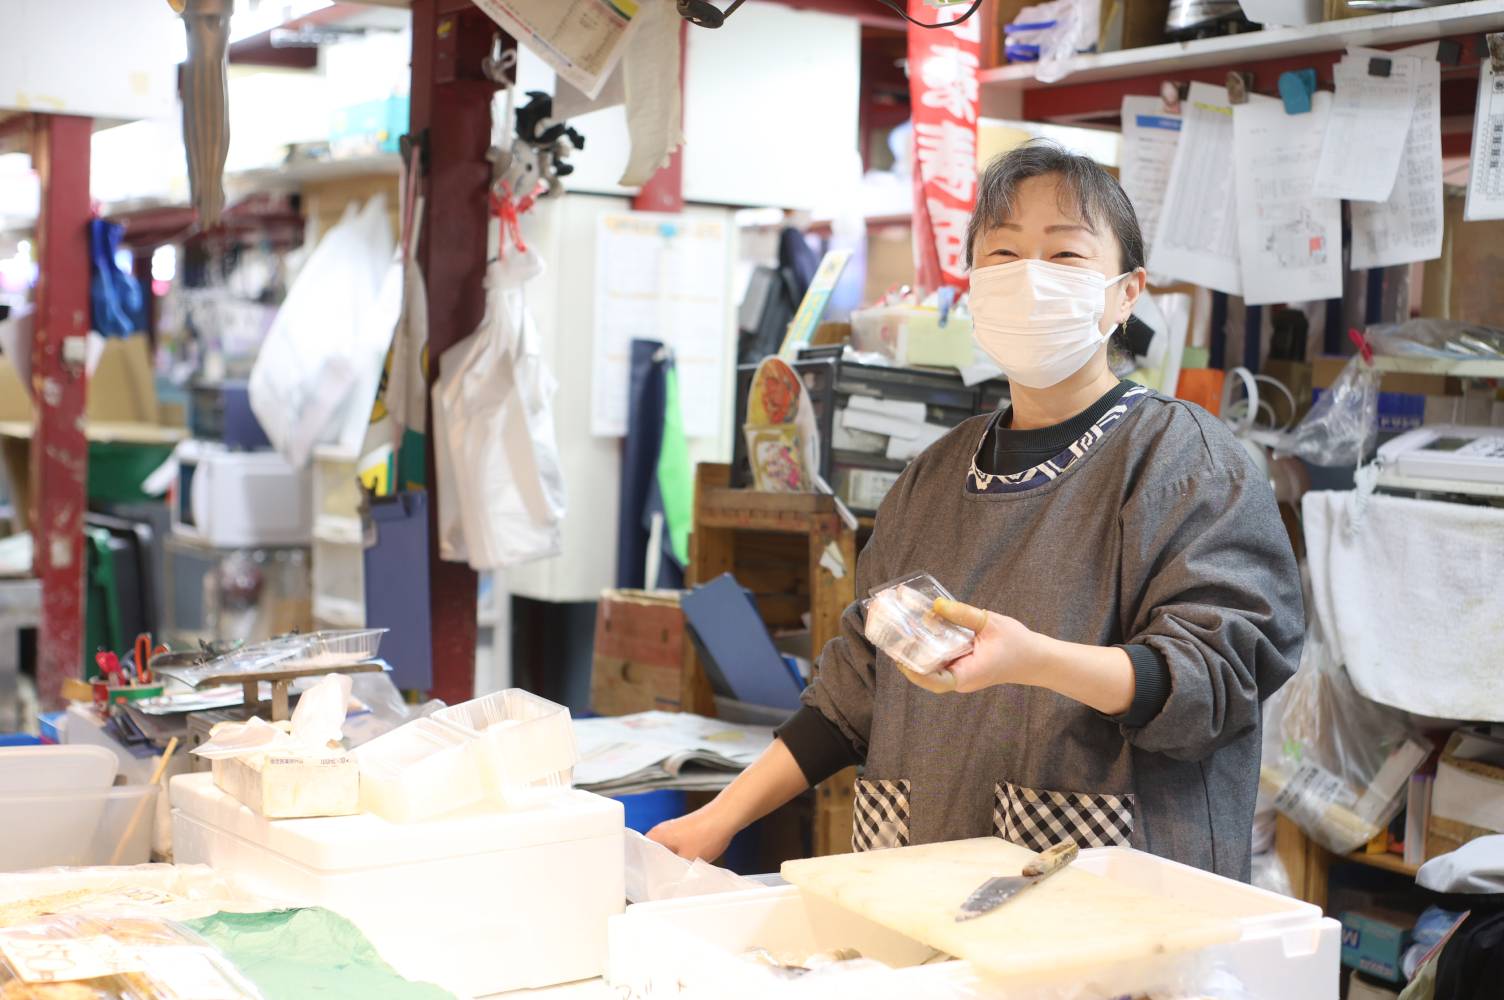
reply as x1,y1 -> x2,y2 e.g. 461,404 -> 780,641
966,138 -> 1145,271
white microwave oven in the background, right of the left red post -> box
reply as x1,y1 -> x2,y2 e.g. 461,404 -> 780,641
171,441 -> 313,549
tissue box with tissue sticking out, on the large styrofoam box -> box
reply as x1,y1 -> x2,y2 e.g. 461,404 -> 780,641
214,749 -> 361,820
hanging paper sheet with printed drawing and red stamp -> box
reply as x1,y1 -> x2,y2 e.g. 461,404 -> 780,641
1233,93 -> 1342,305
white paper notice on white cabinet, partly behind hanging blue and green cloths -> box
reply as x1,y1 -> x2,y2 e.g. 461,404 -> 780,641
590,212 -> 731,438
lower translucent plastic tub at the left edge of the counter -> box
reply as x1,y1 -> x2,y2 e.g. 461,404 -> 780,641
0,781 -> 156,872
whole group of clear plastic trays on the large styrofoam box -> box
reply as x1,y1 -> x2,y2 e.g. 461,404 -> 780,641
355,689 -> 578,823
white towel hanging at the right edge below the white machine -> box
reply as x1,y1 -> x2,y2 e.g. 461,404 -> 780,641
1301,492 -> 1504,722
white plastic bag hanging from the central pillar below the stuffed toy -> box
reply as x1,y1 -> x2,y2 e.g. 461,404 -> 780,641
433,251 -> 564,570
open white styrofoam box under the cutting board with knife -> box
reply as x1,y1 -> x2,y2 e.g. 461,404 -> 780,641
606,847 -> 1342,1000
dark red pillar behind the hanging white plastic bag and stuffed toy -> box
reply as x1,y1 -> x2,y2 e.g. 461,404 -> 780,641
409,0 -> 499,704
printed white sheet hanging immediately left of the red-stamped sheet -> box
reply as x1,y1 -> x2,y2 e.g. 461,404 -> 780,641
1149,83 -> 1242,295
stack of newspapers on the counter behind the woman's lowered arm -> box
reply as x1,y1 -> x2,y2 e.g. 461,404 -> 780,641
575,711 -> 773,795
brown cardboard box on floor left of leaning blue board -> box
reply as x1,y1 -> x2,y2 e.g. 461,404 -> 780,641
590,589 -> 695,716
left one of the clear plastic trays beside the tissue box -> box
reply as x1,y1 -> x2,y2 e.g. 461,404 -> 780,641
355,719 -> 486,823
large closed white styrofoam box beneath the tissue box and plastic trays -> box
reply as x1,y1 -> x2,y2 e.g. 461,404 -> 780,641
171,774 -> 626,995
